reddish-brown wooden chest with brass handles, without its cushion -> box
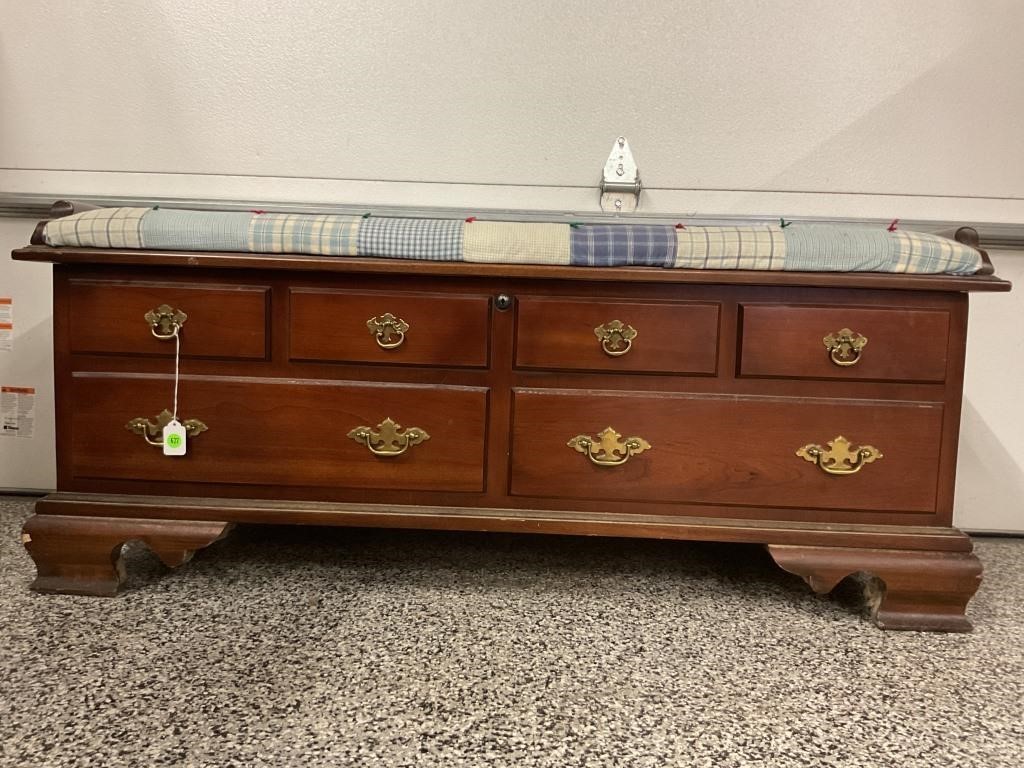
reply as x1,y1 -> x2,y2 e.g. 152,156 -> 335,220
14,217 -> 1010,631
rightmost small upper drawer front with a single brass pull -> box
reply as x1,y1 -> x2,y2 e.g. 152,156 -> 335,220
739,304 -> 949,382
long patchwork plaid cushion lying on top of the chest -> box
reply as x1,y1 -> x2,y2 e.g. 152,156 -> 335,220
43,208 -> 982,274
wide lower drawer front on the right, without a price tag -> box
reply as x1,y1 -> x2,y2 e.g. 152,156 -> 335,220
511,390 -> 943,513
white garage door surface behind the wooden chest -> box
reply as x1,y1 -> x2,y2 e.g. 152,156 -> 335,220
0,0 -> 1024,529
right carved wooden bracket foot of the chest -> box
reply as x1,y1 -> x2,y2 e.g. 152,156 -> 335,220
768,545 -> 981,632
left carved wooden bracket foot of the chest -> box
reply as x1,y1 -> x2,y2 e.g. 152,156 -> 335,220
22,514 -> 230,596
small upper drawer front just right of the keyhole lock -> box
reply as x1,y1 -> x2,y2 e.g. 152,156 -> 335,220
515,297 -> 719,376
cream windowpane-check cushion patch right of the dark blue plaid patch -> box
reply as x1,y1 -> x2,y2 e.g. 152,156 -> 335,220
673,225 -> 785,269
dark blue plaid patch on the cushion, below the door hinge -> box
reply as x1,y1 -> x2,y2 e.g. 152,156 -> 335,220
570,224 -> 676,266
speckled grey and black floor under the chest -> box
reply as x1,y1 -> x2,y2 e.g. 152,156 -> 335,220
0,497 -> 1024,768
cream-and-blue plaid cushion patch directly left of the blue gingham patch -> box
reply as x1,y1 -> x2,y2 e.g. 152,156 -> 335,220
248,213 -> 361,256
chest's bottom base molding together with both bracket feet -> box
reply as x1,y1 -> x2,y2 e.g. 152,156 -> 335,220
24,493 -> 981,632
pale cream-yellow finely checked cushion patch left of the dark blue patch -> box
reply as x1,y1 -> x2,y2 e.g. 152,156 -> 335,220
463,221 -> 569,264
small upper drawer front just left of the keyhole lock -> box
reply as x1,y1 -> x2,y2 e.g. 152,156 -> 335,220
289,289 -> 490,368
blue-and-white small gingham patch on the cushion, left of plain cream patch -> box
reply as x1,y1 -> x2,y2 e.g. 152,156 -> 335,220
357,216 -> 465,261
